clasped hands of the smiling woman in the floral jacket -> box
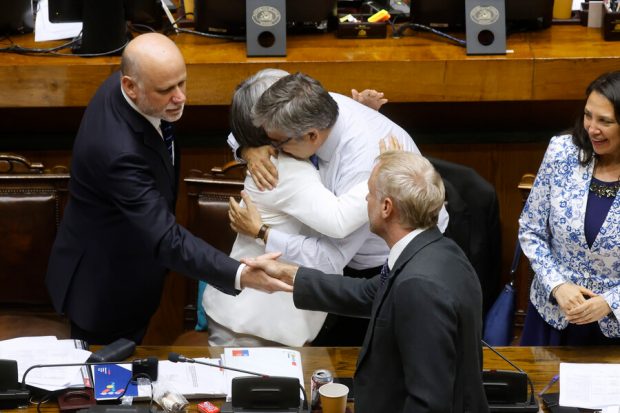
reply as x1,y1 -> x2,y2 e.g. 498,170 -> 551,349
553,283 -> 611,324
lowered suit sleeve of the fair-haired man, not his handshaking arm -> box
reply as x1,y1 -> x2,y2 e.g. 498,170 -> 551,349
394,278 -> 458,413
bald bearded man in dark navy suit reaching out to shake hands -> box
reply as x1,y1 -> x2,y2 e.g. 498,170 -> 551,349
46,33 -> 288,344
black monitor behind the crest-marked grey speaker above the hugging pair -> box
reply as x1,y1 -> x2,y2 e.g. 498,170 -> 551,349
194,0 -> 336,35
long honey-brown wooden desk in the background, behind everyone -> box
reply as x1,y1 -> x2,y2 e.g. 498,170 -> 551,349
0,26 -> 620,107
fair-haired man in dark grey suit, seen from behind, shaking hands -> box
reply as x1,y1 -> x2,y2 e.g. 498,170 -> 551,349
247,152 -> 488,413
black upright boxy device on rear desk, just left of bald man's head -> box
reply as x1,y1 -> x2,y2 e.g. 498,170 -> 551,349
76,0 -> 127,54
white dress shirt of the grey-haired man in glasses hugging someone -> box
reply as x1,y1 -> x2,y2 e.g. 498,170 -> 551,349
266,93 -> 448,274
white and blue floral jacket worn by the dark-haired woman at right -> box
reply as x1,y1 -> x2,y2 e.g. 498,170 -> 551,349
519,135 -> 620,337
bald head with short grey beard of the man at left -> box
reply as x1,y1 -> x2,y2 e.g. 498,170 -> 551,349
121,33 -> 187,122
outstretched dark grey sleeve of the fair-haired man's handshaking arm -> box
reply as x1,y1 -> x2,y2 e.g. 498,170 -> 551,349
293,267 -> 380,318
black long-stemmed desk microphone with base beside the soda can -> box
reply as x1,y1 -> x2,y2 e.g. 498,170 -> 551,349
168,353 -> 308,413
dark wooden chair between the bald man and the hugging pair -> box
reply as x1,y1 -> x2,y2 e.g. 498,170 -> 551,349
174,161 -> 245,346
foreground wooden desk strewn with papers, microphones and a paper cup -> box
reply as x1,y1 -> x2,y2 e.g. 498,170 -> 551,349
14,346 -> 620,413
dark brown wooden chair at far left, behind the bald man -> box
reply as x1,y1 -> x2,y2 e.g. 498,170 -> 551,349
0,154 -> 70,340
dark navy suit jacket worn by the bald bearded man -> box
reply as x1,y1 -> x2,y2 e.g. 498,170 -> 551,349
46,73 -> 239,334
